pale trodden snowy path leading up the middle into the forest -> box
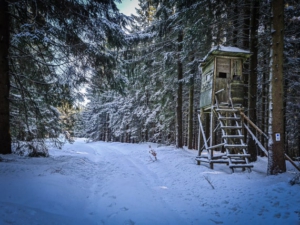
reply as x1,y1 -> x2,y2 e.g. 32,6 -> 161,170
77,142 -> 182,224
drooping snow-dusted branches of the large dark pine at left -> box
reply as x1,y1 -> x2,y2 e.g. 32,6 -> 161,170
0,0 -> 129,153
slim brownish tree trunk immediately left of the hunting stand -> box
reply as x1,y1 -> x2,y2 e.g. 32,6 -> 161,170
188,76 -> 194,149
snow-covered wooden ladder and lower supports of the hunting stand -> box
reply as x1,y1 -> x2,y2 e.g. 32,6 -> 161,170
196,90 -> 253,172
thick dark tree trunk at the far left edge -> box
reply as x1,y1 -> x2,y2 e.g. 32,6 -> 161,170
0,0 -> 11,154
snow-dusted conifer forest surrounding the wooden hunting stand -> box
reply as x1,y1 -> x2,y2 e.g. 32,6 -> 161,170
0,0 -> 300,174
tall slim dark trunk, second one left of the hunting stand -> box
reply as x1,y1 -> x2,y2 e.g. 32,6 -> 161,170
176,30 -> 183,148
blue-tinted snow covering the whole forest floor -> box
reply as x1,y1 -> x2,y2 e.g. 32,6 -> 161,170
0,139 -> 300,225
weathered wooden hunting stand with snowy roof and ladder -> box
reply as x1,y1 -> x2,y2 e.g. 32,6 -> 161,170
196,46 -> 253,172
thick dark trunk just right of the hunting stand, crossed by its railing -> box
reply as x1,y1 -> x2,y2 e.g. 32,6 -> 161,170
247,0 -> 259,162
